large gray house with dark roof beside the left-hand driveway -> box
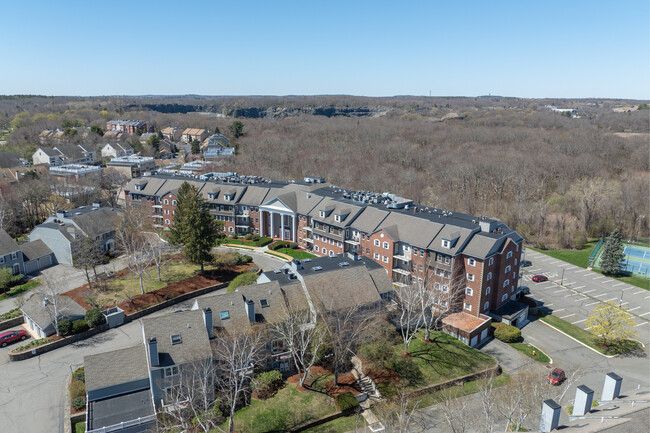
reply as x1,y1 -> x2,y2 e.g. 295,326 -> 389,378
29,203 -> 121,265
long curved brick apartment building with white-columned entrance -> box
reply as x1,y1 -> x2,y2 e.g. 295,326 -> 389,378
124,173 -> 528,346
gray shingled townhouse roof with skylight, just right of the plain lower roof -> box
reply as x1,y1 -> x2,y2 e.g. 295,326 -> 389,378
142,310 -> 212,367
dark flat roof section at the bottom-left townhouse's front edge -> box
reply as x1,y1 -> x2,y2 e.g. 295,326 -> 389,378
88,389 -> 156,433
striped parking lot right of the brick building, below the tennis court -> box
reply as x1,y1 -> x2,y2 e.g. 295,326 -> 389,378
521,249 -> 650,345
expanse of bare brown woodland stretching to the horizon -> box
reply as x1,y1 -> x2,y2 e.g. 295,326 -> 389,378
0,96 -> 650,248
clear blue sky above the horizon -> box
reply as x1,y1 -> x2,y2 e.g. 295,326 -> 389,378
0,0 -> 650,99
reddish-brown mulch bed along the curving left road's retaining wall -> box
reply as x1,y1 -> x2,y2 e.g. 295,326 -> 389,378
64,264 -> 251,314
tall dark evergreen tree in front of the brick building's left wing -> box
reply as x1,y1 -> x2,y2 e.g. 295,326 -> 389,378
171,182 -> 217,272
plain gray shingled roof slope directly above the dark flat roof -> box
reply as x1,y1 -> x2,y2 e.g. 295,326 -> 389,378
84,343 -> 149,391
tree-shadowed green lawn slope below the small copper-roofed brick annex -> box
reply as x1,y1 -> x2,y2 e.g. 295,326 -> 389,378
394,331 -> 496,388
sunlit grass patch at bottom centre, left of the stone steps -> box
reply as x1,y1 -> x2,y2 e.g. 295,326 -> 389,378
222,383 -> 337,433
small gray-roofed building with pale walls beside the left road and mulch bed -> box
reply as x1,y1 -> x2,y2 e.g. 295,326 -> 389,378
20,294 -> 86,338
